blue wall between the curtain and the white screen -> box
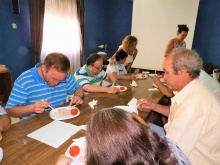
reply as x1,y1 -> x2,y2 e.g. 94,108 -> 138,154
85,0 -> 133,59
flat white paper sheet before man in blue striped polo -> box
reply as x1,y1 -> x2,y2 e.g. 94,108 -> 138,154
27,120 -> 83,148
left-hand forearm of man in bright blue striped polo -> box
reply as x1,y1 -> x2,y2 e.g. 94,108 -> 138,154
6,104 -> 35,118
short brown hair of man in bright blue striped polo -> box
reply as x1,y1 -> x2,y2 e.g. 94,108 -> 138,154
44,52 -> 70,73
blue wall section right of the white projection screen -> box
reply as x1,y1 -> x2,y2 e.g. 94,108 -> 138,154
192,0 -> 220,67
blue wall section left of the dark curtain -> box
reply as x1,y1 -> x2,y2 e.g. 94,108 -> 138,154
0,0 -> 32,80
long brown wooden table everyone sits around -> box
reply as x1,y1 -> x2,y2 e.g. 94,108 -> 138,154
0,77 -> 162,165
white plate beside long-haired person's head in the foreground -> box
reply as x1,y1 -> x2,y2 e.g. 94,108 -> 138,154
65,137 -> 86,165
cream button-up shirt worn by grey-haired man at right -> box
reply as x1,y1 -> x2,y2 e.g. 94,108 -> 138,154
164,79 -> 220,165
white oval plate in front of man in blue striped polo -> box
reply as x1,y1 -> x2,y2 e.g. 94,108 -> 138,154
50,106 -> 80,120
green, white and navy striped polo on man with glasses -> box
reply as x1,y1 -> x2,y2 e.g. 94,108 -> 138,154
74,65 -> 107,87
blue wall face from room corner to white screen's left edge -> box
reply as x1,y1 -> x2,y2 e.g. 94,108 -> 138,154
105,0 -> 133,55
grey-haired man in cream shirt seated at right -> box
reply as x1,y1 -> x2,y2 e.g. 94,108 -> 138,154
137,48 -> 220,165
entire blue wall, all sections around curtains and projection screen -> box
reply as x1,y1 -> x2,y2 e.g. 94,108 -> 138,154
0,0 -> 220,80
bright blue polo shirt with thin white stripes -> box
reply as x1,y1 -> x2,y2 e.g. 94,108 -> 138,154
6,63 -> 80,120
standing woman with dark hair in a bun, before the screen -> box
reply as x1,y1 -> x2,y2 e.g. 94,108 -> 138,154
164,25 -> 189,57
